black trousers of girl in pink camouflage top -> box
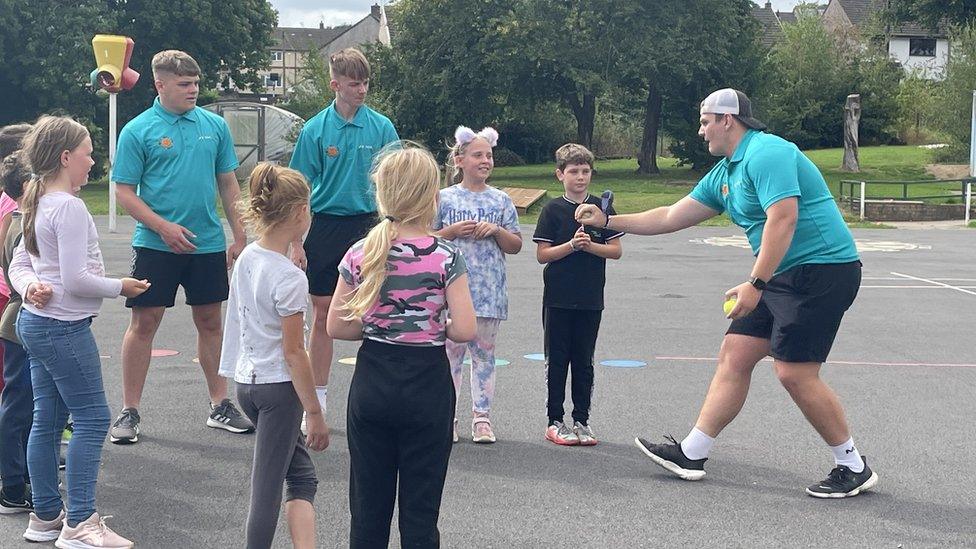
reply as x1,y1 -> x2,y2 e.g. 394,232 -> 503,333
347,339 -> 456,549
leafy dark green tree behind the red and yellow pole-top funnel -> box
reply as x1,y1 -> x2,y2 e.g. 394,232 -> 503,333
0,0 -> 276,123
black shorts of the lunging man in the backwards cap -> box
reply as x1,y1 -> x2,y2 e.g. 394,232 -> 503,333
726,261 -> 861,363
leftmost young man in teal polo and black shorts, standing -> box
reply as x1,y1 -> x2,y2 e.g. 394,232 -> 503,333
110,50 -> 254,444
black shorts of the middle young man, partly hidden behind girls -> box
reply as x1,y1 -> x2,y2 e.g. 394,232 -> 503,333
305,213 -> 376,296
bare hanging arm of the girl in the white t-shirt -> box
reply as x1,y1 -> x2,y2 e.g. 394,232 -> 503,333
281,313 -> 329,452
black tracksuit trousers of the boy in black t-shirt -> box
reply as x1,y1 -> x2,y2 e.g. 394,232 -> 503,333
542,307 -> 603,425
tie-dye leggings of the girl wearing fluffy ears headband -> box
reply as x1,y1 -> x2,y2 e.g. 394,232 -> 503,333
447,316 -> 501,414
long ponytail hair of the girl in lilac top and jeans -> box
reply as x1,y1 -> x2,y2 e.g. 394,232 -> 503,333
20,116 -> 88,256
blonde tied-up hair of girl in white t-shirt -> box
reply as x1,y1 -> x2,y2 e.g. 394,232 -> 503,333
237,162 -> 309,237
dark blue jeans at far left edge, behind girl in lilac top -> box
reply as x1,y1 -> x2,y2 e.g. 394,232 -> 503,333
0,339 -> 34,496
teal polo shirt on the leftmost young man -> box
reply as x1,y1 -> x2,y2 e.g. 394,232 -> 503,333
112,97 -> 238,254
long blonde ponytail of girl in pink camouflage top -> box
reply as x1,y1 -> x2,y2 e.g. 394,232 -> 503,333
345,141 -> 440,320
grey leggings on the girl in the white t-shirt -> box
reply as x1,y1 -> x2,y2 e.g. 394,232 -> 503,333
237,382 -> 318,549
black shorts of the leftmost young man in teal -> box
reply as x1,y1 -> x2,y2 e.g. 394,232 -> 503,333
125,248 -> 230,307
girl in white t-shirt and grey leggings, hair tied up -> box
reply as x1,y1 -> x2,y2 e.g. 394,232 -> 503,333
220,164 -> 329,548
